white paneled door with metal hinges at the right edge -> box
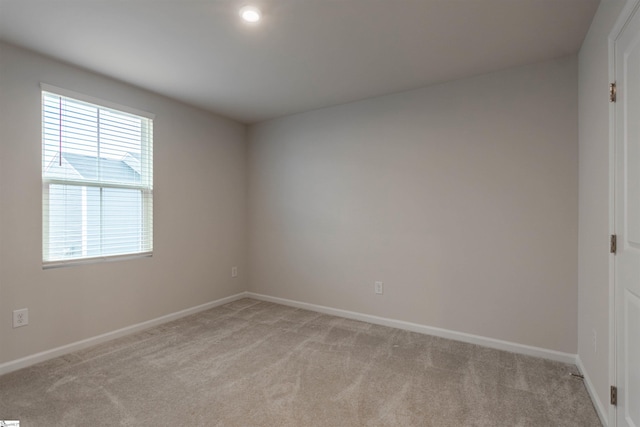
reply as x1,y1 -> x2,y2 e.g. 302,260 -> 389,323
615,4 -> 640,427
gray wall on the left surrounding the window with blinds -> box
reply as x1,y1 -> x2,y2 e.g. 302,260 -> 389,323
0,44 -> 247,363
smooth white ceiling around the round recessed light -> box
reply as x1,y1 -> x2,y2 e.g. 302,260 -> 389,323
0,0 -> 599,123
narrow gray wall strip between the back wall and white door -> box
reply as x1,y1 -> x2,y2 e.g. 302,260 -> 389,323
578,0 -> 625,408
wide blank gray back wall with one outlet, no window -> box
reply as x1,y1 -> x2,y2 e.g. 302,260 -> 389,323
248,56 -> 578,353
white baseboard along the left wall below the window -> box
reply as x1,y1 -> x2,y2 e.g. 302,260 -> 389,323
0,292 -> 247,375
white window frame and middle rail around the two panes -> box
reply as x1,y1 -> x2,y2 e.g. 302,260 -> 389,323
40,83 -> 155,269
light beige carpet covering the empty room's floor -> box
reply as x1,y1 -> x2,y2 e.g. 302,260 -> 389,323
0,299 -> 600,427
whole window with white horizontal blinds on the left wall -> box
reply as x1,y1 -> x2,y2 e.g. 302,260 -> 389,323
42,85 -> 153,266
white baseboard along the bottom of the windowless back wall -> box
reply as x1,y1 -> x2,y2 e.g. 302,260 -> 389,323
245,292 -> 576,364
